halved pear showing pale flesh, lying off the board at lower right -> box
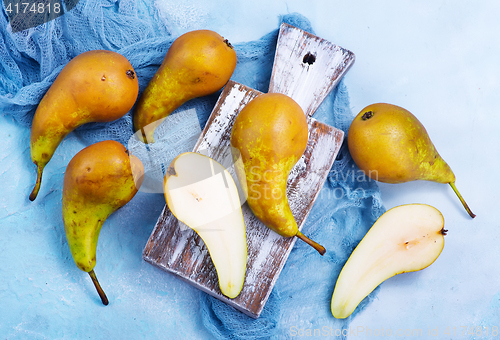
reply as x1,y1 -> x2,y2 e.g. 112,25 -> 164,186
332,204 -> 446,319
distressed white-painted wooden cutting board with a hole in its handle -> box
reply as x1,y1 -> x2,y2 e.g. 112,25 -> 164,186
143,24 -> 354,318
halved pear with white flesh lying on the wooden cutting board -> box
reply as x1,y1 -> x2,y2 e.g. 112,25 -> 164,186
164,152 -> 247,298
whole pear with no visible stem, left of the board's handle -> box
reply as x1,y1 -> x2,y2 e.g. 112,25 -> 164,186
134,30 -> 237,143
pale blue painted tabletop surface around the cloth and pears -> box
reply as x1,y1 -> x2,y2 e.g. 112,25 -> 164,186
0,0 -> 500,339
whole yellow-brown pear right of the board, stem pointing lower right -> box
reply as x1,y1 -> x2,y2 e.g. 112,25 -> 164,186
347,103 -> 476,218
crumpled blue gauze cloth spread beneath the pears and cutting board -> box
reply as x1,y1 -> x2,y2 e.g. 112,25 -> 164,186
0,0 -> 385,339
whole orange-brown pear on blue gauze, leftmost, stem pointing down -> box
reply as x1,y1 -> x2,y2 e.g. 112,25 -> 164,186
29,50 -> 139,201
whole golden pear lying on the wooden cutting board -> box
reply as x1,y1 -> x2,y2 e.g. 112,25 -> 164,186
230,93 -> 325,255
